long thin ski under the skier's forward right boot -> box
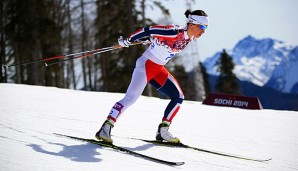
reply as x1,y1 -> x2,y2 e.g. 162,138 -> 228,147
129,138 -> 271,162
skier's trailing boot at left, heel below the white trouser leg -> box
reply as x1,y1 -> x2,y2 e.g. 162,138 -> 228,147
95,120 -> 114,144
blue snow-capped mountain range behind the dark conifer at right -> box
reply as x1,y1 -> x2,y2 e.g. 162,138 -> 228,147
204,36 -> 298,94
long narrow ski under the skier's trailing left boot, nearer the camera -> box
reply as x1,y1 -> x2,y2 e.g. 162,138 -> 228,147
54,133 -> 184,166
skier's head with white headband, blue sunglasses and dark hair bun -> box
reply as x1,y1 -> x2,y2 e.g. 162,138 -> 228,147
184,10 -> 208,38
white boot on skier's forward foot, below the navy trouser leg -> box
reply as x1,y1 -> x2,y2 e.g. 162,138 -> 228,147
156,122 -> 180,143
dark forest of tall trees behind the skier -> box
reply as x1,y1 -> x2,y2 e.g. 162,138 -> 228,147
0,0 -> 239,100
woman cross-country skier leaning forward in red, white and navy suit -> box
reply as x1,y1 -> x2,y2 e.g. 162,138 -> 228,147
95,10 -> 208,143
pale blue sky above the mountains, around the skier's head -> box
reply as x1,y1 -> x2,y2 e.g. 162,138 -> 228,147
146,0 -> 298,60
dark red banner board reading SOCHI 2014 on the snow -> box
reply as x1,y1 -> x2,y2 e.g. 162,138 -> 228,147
203,93 -> 263,109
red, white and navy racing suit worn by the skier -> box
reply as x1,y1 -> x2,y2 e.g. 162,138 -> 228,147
108,25 -> 192,123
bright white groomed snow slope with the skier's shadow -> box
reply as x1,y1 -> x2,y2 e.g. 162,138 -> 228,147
0,84 -> 298,171
